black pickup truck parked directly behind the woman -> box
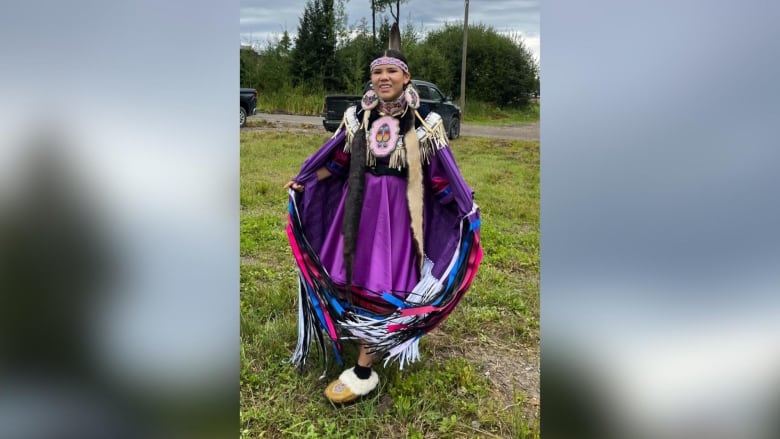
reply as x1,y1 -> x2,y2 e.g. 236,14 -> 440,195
322,79 -> 461,140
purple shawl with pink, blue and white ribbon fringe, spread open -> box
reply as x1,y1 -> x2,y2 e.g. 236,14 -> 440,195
287,107 -> 482,374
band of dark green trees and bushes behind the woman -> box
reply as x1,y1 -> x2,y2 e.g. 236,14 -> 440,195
256,4 -> 539,106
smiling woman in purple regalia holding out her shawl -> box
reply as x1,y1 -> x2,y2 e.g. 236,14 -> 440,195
285,49 -> 482,403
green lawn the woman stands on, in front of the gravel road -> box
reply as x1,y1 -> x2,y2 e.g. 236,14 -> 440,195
240,131 -> 539,438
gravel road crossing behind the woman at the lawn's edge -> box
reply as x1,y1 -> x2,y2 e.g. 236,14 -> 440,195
245,113 -> 539,141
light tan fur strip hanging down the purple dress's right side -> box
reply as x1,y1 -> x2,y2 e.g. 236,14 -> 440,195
404,112 -> 425,270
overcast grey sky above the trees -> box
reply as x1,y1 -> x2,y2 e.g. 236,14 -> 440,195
241,0 -> 540,60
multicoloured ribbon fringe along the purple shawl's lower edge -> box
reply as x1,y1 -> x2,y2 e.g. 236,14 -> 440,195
287,190 -> 482,376
